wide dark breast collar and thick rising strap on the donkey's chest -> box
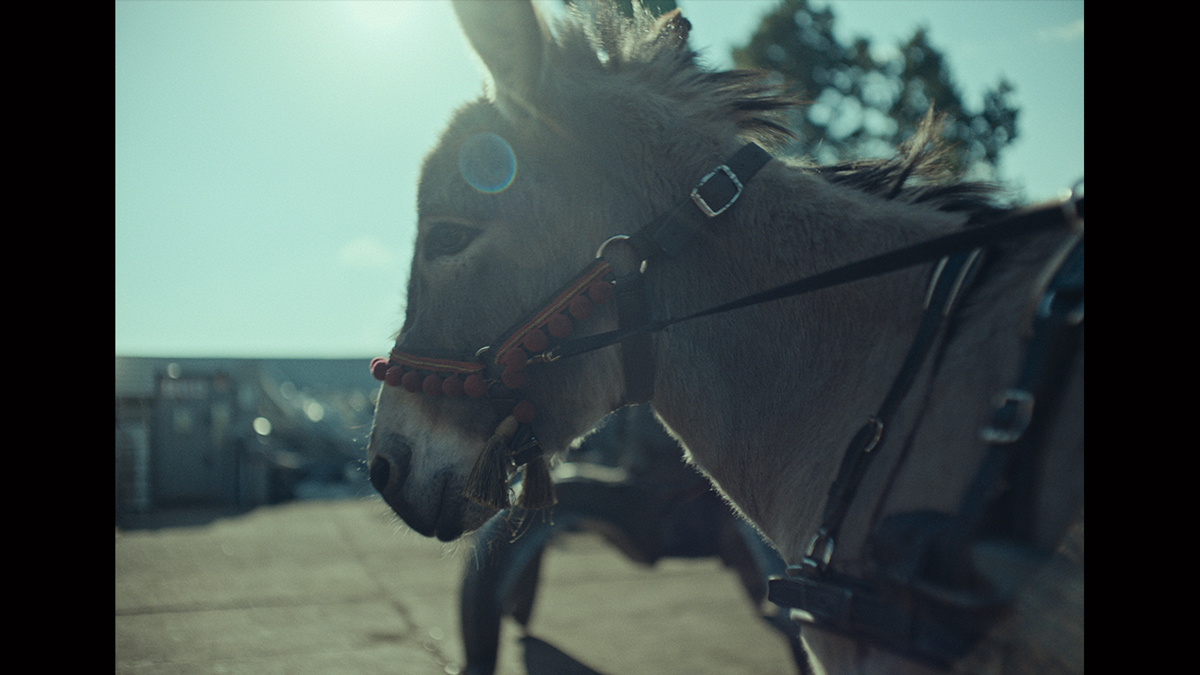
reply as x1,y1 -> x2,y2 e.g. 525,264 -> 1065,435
768,223 -> 1084,665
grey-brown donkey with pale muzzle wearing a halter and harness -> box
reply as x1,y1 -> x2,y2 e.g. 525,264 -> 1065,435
368,1 -> 1084,673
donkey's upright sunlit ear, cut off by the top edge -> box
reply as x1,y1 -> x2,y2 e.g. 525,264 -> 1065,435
454,0 -> 546,109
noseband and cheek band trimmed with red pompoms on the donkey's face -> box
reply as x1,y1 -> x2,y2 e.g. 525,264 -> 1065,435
371,259 -> 613,424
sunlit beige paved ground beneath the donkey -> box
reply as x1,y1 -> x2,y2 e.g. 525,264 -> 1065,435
115,500 -> 796,675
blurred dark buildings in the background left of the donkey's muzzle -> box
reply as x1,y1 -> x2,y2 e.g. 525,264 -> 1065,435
115,357 -> 379,524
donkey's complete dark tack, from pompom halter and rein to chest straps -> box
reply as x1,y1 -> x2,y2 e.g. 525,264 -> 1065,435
371,143 -> 1084,664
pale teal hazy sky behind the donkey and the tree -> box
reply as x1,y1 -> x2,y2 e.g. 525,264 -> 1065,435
114,0 -> 1084,359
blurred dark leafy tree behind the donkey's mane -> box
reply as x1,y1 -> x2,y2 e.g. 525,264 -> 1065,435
733,0 -> 1019,179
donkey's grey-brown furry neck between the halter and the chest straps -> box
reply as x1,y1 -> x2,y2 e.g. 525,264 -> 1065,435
647,154 -> 959,557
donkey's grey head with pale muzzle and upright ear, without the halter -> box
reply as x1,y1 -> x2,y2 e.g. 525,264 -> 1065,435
368,2 -> 685,540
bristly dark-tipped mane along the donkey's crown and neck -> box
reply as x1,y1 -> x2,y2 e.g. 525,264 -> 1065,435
554,2 -> 1007,225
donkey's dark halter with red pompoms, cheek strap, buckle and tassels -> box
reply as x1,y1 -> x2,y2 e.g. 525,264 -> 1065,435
371,143 -> 770,509
